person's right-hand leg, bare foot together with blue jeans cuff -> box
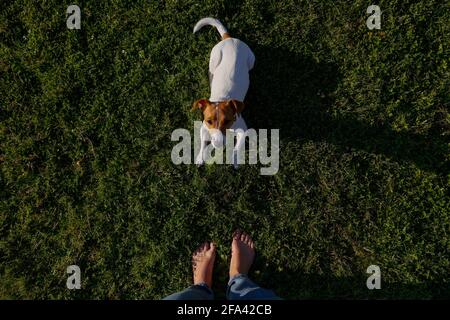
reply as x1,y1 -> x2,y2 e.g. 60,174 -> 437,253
227,230 -> 280,300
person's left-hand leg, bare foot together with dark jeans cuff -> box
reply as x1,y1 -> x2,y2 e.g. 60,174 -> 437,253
163,242 -> 216,300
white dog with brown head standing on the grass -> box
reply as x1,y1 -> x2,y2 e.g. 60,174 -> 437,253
192,18 -> 255,168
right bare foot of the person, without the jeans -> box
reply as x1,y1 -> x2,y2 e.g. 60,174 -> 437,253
230,229 -> 255,278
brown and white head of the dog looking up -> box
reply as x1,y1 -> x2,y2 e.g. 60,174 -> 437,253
192,99 -> 244,148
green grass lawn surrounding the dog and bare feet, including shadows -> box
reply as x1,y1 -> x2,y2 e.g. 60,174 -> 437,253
0,0 -> 450,299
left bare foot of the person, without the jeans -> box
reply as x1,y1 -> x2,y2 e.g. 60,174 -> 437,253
192,242 -> 216,288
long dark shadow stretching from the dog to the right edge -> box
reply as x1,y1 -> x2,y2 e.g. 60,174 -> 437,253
244,43 -> 447,172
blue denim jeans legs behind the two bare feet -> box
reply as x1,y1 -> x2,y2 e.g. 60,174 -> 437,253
163,274 -> 280,300
